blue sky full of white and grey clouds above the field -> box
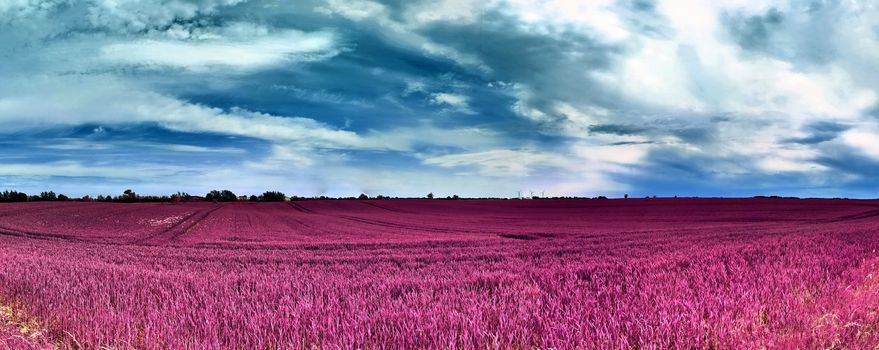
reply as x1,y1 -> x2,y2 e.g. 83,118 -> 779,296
0,0 -> 879,198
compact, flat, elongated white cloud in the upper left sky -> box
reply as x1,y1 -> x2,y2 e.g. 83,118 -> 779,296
101,30 -> 338,71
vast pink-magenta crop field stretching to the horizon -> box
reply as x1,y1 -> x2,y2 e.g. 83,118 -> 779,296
0,199 -> 879,349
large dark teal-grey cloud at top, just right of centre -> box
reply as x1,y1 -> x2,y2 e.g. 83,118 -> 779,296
424,9 -> 628,120
